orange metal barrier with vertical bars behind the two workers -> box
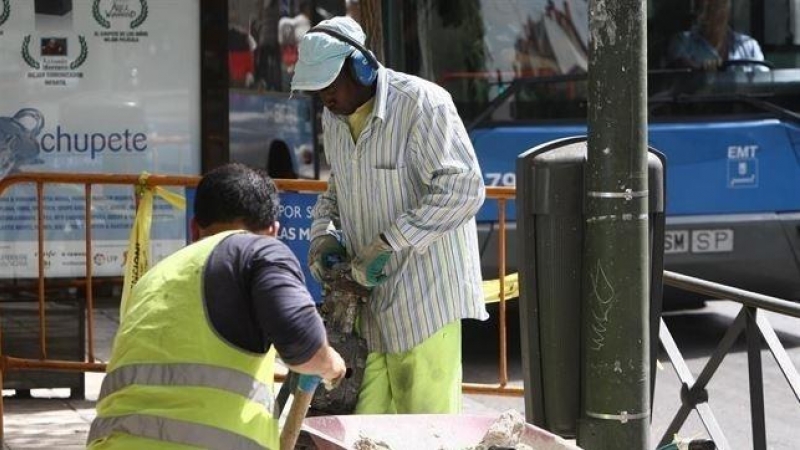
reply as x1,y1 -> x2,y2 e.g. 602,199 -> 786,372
0,172 -> 523,439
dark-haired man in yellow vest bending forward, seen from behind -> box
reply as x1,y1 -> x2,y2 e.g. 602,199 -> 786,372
88,164 -> 345,450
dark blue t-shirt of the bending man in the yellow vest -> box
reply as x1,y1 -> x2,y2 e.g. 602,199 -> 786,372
203,233 -> 325,365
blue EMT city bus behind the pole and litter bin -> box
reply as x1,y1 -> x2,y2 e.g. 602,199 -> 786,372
384,0 -> 800,300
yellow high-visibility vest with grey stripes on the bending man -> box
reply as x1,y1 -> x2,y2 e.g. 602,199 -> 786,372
88,232 -> 279,450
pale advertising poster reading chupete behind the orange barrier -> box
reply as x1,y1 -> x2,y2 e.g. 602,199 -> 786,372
0,0 -> 200,278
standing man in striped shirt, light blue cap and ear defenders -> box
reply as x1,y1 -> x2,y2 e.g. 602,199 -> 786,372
292,17 -> 488,414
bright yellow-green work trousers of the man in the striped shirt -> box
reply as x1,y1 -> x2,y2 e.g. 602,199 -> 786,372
356,320 -> 461,414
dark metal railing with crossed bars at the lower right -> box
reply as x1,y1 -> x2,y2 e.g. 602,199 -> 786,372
659,271 -> 800,450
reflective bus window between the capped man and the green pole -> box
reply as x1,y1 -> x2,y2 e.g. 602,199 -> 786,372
403,0 -> 588,121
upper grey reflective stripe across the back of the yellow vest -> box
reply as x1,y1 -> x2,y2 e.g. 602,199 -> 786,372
98,363 -> 275,413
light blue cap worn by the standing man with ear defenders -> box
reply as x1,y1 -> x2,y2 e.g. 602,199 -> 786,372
292,16 -> 367,91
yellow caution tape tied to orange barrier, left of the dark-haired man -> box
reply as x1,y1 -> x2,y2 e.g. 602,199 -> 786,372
120,172 -> 186,314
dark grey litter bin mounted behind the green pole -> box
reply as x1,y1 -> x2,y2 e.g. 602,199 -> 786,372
517,137 -> 666,437
